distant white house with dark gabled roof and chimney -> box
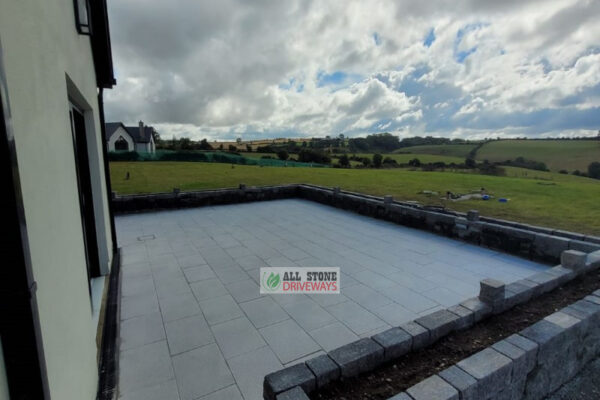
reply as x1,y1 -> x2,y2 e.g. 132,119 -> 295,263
106,121 -> 156,153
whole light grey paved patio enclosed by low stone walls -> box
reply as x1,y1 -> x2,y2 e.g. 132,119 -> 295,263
116,200 -> 546,400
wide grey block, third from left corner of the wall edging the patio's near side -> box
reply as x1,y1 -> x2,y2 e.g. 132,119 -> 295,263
329,338 -> 384,378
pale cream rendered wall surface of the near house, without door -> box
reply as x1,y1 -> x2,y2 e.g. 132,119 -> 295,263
0,0 -> 112,400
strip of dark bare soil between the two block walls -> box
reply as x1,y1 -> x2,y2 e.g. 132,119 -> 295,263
311,271 -> 600,400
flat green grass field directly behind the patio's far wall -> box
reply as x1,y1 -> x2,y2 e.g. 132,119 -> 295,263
110,162 -> 600,235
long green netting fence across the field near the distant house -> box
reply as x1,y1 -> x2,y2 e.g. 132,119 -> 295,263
108,150 -> 329,168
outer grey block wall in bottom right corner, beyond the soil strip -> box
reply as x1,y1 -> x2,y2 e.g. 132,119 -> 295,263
390,290 -> 600,400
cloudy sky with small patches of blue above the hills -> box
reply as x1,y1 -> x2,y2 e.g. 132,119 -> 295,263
105,0 -> 600,140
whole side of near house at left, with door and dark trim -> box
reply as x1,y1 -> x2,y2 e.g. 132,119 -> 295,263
0,0 -> 118,400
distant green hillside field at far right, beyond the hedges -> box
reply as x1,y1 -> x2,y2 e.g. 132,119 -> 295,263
476,140 -> 600,172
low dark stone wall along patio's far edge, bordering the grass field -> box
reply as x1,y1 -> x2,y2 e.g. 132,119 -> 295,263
112,184 -> 600,265
